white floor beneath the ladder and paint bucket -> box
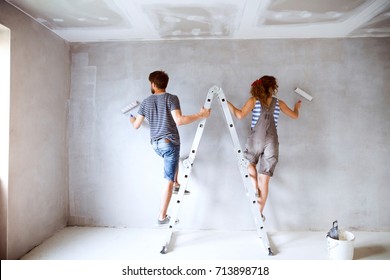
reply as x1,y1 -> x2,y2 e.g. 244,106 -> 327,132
21,227 -> 390,260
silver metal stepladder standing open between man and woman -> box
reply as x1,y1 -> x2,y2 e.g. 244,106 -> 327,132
160,86 -> 273,256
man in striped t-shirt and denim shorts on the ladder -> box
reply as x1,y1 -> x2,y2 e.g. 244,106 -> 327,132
130,71 -> 210,225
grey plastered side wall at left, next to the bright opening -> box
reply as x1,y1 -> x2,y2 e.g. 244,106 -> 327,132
0,1 -> 70,259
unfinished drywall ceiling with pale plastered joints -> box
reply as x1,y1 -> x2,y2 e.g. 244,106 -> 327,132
6,0 -> 390,42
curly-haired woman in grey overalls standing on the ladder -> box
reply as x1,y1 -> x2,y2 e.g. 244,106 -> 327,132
228,76 -> 301,221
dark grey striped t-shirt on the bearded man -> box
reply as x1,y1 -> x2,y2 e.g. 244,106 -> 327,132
138,92 -> 180,144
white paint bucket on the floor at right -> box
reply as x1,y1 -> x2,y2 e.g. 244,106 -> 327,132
326,230 -> 355,260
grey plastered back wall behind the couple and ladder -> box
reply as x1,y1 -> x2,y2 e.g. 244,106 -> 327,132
69,38 -> 390,231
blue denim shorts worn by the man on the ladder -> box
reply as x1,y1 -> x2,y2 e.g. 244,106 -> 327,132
152,138 -> 180,182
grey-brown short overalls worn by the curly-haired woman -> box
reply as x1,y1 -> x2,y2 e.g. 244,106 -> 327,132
244,97 -> 279,176
